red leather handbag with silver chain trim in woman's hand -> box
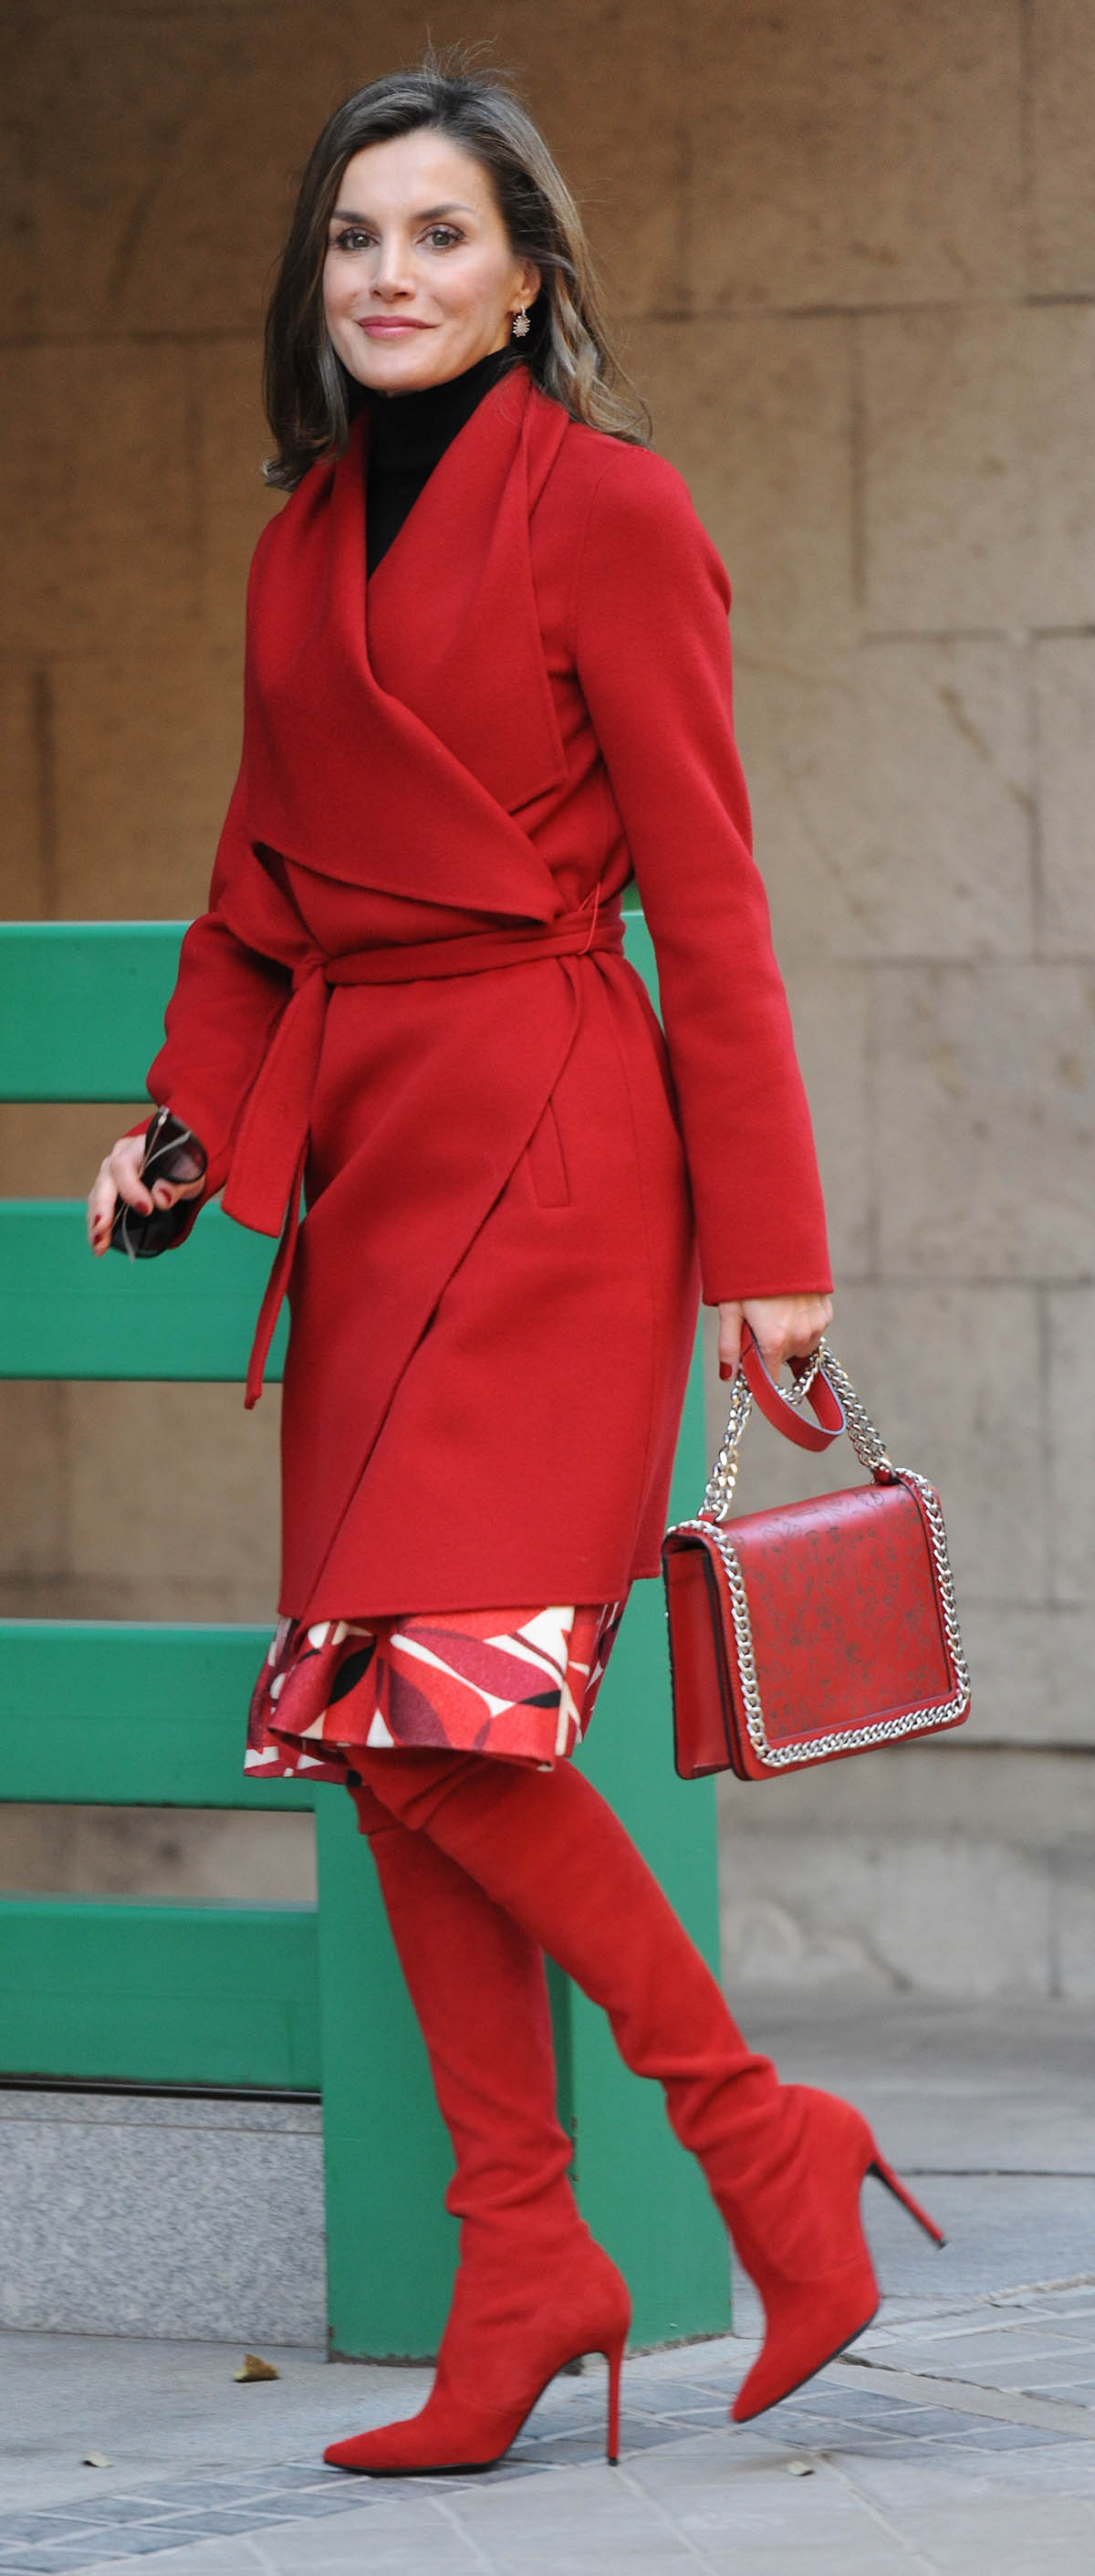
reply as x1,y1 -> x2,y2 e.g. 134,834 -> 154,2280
662,1332 -> 969,1780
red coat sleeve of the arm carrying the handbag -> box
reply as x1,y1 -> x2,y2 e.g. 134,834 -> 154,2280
575,445 -> 829,1304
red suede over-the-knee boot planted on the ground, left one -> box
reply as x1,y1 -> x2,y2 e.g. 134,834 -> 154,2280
325,1798 -> 631,2478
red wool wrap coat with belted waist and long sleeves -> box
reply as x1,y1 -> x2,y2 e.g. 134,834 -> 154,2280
150,369 -> 829,1620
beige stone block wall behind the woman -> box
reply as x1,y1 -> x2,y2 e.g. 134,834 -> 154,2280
0,0 -> 1095,1991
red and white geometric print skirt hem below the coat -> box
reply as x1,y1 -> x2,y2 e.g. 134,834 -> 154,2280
245,1602 -> 623,1783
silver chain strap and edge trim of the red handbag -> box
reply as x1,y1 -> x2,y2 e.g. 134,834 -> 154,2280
683,1342 -> 969,1770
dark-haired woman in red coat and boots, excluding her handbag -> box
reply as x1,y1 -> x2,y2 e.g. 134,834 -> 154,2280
88,65 -> 937,2476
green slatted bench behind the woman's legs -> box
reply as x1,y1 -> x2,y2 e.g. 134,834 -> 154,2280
0,915 -> 729,2357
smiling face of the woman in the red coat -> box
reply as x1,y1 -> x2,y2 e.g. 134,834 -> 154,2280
322,126 -> 541,394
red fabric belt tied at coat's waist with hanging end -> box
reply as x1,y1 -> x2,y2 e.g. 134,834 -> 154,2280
224,902 -> 623,1407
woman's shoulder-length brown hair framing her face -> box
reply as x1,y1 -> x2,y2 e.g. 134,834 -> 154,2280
263,54 -> 650,492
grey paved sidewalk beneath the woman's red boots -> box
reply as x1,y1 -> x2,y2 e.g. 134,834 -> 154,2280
0,2002 -> 1095,2576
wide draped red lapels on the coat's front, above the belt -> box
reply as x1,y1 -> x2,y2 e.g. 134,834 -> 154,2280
245,379 -> 567,919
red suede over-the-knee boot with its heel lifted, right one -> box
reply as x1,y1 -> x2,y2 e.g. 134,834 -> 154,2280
352,1752 -> 943,2422
